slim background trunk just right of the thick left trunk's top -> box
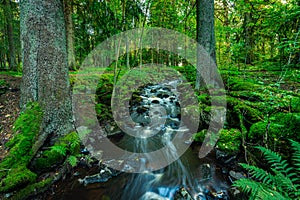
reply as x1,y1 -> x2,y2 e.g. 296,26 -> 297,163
64,0 -> 76,70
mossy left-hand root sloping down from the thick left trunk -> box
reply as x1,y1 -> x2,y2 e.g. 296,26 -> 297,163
0,102 -> 43,192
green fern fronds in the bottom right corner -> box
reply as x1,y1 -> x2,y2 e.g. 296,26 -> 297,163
234,140 -> 300,200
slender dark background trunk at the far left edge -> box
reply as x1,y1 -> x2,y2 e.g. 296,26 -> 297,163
4,0 -> 17,71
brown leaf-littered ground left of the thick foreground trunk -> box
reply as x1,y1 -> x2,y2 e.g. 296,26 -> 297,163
0,74 -> 21,161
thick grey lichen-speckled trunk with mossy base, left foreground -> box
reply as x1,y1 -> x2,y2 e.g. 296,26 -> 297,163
20,0 -> 73,138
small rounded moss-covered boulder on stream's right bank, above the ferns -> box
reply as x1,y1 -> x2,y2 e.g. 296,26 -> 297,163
217,129 -> 242,153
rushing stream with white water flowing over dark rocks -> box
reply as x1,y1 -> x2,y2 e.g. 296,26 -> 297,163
42,81 -> 229,200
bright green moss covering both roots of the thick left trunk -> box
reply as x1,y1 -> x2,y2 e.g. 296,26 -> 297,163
0,102 -> 80,199
